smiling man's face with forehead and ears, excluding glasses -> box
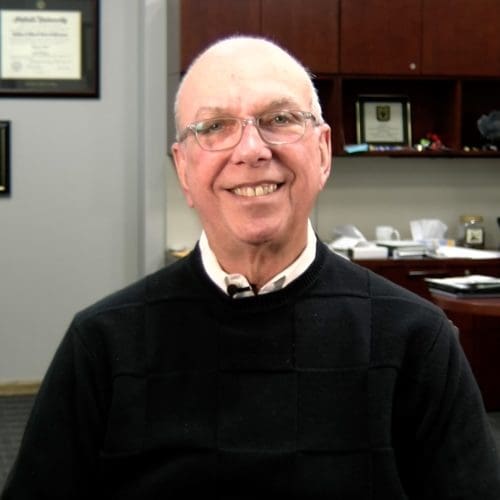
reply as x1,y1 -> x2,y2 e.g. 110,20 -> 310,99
172,44 -> 331,248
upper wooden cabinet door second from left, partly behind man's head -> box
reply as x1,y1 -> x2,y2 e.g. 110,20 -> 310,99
262,0 -> 339,73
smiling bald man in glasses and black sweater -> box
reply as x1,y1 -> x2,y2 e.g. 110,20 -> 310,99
2,37 -> 500,500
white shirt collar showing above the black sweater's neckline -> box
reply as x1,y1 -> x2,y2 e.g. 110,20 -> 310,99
200,221 -> 316,298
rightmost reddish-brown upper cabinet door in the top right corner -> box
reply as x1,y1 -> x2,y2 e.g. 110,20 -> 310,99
422,0 -> 500,76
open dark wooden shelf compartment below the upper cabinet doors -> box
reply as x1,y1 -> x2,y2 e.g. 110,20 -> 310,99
315,74 -> 500,158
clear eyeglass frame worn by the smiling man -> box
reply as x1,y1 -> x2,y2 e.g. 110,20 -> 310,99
177,109 -> 321,153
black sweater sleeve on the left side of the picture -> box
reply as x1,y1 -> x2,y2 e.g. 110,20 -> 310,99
1,322 -> 105,500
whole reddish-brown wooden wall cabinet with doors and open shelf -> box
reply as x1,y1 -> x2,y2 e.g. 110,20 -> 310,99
180,0 -> 500,158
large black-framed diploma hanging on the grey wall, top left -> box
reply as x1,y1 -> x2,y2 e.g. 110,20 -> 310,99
0,0 -> 99,97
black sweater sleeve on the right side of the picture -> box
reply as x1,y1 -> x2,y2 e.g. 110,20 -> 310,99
395,319 -> 500,500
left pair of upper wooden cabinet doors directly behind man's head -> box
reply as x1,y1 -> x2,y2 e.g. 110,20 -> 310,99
181,0 -> 339,73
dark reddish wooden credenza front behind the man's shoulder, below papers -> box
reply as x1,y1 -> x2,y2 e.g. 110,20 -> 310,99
356,258 -> 500,300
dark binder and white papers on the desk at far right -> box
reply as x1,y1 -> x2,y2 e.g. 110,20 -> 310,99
425,274 -> 500,298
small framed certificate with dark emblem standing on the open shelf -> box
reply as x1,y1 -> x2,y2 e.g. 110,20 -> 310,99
356,94 -> 411,146
